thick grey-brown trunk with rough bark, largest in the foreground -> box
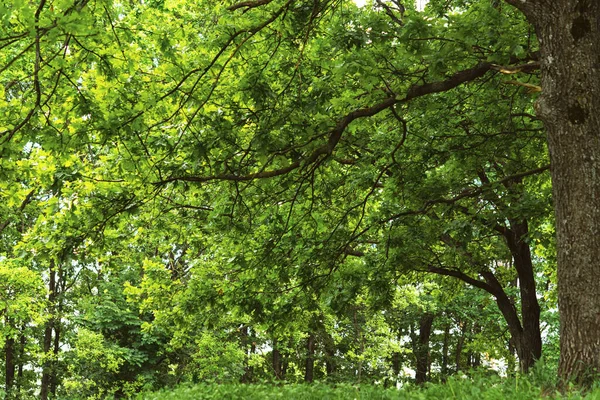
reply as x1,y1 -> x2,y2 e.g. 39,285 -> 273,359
507,0 -> 600,384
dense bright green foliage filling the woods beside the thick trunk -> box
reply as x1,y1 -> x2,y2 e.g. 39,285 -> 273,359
0,0 -> 572,398
